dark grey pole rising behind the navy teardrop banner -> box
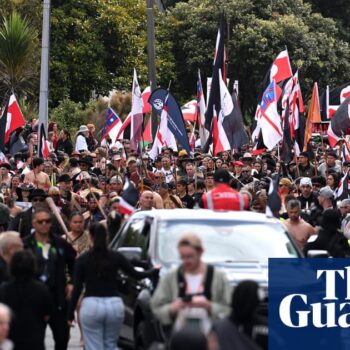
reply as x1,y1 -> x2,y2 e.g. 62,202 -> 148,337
146,0 -> 158,140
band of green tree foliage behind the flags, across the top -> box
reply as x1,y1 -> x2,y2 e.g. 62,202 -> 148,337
0,0 -> 350,131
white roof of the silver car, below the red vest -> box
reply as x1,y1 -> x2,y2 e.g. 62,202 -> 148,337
131,209 -> 280,224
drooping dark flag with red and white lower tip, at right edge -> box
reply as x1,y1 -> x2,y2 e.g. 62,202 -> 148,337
327,96 -> 350,147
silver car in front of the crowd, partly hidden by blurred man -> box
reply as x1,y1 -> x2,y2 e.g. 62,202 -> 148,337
111,209 -> 302,349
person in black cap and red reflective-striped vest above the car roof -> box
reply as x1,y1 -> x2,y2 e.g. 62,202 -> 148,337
200,169 -> 249,210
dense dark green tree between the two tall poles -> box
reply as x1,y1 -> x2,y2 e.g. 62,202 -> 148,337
50,0 -> 173,106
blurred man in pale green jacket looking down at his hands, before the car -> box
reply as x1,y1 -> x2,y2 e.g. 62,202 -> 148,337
151,233 -> 231,332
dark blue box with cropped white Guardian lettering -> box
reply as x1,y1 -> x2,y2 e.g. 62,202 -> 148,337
269,258 -> 350,350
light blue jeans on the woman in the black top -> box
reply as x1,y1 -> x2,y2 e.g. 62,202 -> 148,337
80,297 -> 124,350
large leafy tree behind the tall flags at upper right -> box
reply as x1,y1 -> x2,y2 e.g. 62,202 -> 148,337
167,0 -> 350,115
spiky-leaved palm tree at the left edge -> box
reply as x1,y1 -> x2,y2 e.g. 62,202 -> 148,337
0,12 -> 38,100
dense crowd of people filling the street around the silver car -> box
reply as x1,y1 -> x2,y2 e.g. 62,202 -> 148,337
0,122 -> 350,350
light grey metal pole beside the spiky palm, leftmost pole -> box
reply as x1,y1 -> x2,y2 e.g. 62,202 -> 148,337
39,0 -> 51,136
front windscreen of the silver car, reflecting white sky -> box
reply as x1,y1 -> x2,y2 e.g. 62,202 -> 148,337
157,219 -> 298,264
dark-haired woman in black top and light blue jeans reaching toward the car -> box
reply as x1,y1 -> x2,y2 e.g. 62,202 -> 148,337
68,223 -> 158,350
